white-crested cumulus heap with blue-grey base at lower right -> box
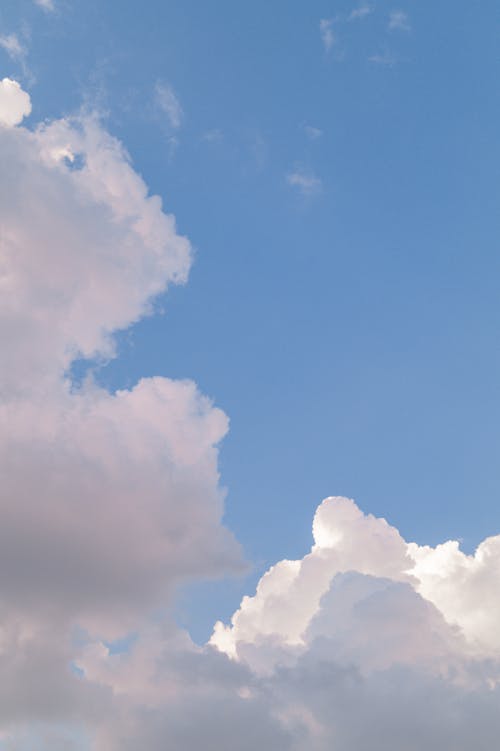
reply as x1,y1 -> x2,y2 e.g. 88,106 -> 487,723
203,498 -> 500,751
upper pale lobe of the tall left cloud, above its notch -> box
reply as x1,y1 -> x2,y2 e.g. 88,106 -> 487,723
0,113 -> 190,392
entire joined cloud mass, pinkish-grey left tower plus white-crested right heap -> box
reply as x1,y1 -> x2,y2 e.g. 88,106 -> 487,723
0,79 -> 500,751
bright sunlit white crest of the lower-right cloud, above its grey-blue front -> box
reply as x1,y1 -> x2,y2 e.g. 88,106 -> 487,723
212,498 -> 500,657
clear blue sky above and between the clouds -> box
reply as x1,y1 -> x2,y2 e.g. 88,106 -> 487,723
0,0 -> 500,637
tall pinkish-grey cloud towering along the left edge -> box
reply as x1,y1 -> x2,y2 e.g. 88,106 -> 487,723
0,79 -> 241,748
